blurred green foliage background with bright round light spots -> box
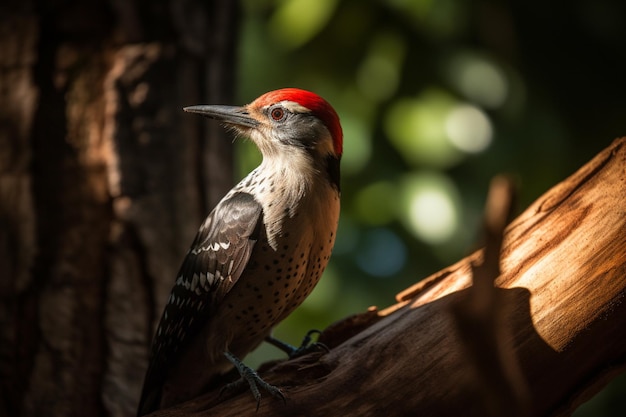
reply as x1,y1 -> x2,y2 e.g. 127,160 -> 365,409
237,0 -> 626,415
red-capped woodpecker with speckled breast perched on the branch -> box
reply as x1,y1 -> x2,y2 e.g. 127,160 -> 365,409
138,88 -> 343,416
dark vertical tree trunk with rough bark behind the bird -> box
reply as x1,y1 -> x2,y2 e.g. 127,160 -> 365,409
0,0 -> 237,416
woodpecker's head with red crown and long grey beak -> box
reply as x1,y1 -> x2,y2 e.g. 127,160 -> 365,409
184,88 -> 343,161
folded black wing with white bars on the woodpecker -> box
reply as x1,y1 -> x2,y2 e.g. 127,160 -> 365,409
138,192 -> 263,416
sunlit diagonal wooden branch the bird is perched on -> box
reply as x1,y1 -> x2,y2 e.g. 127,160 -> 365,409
153,138 -> 626,417
